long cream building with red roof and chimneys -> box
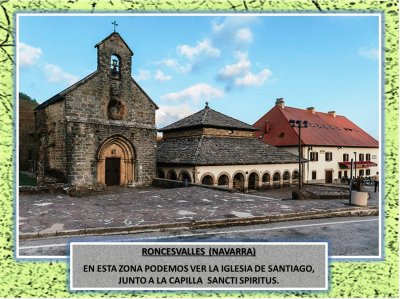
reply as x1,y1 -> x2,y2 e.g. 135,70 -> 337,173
253,98 -> 379,183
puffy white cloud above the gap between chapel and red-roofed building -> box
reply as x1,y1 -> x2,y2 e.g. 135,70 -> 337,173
217,52 -> 272,90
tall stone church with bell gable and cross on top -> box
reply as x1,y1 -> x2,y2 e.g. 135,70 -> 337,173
35,32 -> 158,186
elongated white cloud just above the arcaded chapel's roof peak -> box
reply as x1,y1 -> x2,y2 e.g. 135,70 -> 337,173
161,83 -> 224,103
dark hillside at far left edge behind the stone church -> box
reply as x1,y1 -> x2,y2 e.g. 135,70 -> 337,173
18,92 -> 39,170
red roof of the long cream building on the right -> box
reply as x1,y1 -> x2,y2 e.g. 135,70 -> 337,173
253,105 -> 379,148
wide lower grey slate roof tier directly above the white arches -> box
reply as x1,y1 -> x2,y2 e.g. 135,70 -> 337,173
157,136 -> 298,165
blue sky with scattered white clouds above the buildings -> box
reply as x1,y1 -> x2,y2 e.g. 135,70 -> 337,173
17,14 -> 381,139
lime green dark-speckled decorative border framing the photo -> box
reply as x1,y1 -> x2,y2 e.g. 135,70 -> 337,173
0,0 -> 399,298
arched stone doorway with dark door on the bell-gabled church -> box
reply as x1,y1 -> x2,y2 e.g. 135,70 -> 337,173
97,136 -> 135,186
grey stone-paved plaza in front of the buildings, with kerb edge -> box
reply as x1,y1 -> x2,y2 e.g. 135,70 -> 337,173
19,186 -> 379,239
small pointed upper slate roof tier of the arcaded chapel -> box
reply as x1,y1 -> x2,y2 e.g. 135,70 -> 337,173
158,105 -> 258,132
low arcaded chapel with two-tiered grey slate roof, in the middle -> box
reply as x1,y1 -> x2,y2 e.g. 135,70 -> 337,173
157,105 -> 298,191
